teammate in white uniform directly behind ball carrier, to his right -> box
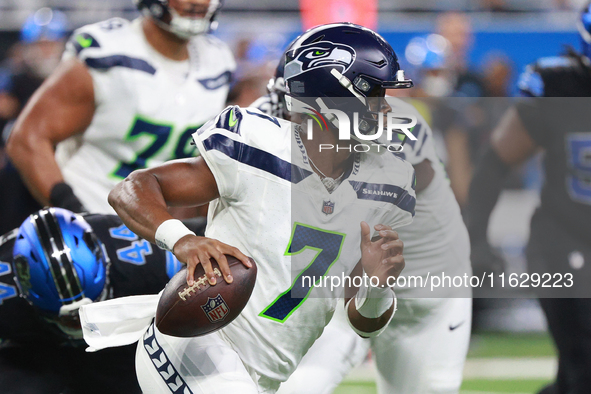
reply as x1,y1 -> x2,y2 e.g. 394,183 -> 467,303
366,99 -> 472,394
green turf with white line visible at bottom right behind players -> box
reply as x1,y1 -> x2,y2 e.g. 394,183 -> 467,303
334,334 -> 556,394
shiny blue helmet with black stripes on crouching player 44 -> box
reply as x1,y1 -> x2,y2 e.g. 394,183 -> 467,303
13,208 -> 110,337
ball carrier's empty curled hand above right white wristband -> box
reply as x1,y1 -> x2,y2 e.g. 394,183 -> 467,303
361,222 -> 404,287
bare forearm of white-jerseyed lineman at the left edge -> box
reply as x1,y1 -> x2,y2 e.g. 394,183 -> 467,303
6,132 -> 64,205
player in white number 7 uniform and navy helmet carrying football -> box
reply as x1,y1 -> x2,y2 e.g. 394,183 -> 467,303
109,24 -> 415,393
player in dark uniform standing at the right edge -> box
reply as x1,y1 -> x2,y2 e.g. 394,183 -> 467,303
467,6 -> 591,394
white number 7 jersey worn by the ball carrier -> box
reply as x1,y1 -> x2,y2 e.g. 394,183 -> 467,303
194,106 -> 415,381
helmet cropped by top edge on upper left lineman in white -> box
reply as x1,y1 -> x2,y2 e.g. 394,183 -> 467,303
133,0 -> 222,39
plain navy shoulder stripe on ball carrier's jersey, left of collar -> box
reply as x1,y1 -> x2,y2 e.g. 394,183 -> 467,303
203,134 -> 312,183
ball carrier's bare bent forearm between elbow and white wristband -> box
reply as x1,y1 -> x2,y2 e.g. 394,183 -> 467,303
108,170 -> 173,242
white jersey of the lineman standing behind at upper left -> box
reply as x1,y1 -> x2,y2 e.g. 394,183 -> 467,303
56,18 -> 235,213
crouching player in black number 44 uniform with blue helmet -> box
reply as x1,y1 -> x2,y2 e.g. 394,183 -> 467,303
0,208 -> 204,394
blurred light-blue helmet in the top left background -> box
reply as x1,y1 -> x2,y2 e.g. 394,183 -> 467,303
21,7 -> 68,44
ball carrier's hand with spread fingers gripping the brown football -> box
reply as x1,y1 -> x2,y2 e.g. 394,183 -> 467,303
173,235 -> 252,286
